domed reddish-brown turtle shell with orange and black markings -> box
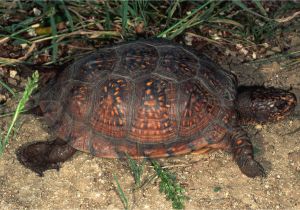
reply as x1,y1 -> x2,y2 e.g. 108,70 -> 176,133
39,40 -> 236,158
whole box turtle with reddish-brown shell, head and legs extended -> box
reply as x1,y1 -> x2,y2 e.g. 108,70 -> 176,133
17,39 -> 297,178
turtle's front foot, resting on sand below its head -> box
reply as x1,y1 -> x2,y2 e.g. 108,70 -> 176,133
237,157 -> 267,178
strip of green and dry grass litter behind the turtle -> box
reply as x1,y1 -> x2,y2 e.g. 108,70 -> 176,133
0,0 -> 299,65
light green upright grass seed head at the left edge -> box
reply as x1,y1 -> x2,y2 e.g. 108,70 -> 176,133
0,71 -> 39,155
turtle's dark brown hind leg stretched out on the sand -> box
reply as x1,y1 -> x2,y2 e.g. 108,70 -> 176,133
16,139 -> 77,176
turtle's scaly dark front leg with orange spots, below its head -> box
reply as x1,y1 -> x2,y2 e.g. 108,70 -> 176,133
231,128 -> 266,178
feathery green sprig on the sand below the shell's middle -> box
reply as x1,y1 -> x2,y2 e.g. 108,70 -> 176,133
151,160 -> 186,209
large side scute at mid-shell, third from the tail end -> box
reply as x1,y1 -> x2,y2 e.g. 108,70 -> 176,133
129,77 -> 177,143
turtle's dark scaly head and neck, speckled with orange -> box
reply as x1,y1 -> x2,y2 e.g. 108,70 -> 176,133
237,86 -> 297,122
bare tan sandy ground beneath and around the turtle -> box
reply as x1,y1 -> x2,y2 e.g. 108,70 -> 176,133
0,48 -> 300,209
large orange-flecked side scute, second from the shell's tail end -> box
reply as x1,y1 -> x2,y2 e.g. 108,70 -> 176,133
90,78 -> 131,138
